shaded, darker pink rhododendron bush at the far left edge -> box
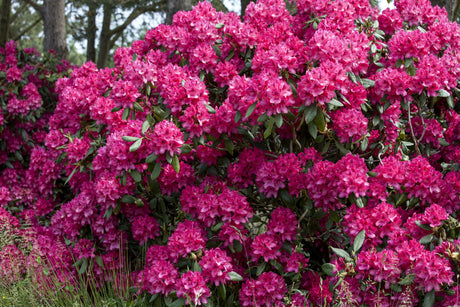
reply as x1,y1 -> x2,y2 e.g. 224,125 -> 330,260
0,41 -> 75,288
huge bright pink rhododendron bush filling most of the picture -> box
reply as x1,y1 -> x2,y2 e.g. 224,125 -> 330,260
1,0 -> 460,306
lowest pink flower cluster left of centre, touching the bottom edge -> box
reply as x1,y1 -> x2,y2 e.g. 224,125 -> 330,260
177,271 -> 211,306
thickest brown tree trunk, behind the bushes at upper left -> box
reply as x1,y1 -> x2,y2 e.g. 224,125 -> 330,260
41,0 -> 68,59
